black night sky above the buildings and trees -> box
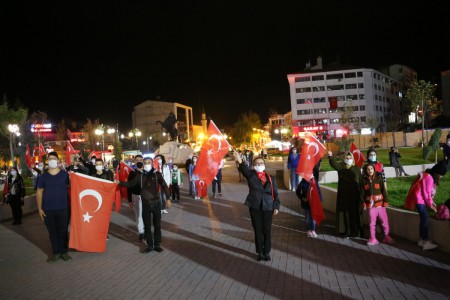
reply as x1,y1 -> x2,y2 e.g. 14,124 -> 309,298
0,0 -> 450,131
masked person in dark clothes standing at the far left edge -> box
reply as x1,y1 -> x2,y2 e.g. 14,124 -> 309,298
3,167 -> 25,225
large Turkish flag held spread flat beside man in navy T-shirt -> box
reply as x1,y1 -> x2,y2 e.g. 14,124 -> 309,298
69,172 -> 117,252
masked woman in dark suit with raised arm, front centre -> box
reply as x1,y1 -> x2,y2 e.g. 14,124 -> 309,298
233,150 -> 280,261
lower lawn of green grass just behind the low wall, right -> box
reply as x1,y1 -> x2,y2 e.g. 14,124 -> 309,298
322,174 -> 450,208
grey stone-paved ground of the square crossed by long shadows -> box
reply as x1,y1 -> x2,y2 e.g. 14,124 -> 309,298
0,162 -> 450,300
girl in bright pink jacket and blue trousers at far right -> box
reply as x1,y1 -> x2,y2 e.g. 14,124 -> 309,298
405,161 -> 447,250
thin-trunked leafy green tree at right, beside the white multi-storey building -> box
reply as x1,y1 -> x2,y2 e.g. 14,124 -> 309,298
405,80 -> 434,146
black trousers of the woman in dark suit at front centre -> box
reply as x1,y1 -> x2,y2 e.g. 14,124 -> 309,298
249,207 -> 273,255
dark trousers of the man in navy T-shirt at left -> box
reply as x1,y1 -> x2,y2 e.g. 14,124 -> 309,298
44,208 -> 69,254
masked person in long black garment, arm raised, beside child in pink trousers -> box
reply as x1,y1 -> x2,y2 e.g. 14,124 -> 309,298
328,151 -> 363,238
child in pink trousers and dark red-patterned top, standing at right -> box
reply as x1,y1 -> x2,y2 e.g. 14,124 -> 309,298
361,164 -> 394,246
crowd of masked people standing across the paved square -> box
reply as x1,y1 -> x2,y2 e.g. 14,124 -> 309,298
3,135 -> 450,262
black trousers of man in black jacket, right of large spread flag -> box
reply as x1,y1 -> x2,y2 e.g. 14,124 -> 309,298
142,201 -> 161,247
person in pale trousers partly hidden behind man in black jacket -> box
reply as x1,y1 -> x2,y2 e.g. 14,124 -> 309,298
127,154 -> 145,242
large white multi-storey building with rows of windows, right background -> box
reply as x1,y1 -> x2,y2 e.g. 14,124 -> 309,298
287,58 -> 403,136
